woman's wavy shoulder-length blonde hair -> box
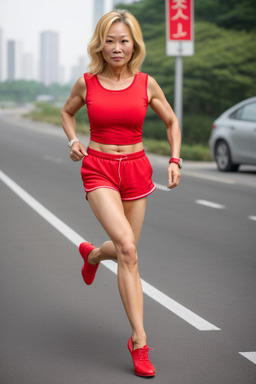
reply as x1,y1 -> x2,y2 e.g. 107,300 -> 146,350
88,9 -> 146,75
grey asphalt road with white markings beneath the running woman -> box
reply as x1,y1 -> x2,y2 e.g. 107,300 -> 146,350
0,112 -> 256,384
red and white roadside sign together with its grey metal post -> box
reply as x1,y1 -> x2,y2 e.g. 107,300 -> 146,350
165,0 -> 194,132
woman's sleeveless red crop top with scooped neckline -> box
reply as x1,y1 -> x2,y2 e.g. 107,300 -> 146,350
84,72 -> 148,145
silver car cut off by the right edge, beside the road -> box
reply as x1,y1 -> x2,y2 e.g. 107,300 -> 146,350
209,97 -> 256,172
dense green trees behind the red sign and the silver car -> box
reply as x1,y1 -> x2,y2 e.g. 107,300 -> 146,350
116,0 -> 256,143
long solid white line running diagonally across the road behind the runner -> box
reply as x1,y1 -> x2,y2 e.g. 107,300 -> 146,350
0,170 -> 220,331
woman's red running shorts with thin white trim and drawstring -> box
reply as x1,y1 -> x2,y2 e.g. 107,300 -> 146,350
81,148 -> 156,200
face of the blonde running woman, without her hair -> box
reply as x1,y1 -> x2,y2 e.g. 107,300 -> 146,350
102,22 -> 134,68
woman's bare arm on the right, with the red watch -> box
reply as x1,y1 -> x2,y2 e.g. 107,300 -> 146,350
148,76 -> 181,189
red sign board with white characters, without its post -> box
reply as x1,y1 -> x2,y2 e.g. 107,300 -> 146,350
165,0 -> 194,56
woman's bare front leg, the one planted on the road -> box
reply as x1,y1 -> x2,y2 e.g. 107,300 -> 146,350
88,188 -> 146,348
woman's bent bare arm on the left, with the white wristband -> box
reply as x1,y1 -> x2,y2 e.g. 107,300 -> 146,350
61,76 -> 87,161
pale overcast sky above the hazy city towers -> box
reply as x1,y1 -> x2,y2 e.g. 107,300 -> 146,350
0,0 -> 96,80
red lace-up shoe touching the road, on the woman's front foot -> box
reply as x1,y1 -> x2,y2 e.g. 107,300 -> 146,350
127,338 -> 155,377
